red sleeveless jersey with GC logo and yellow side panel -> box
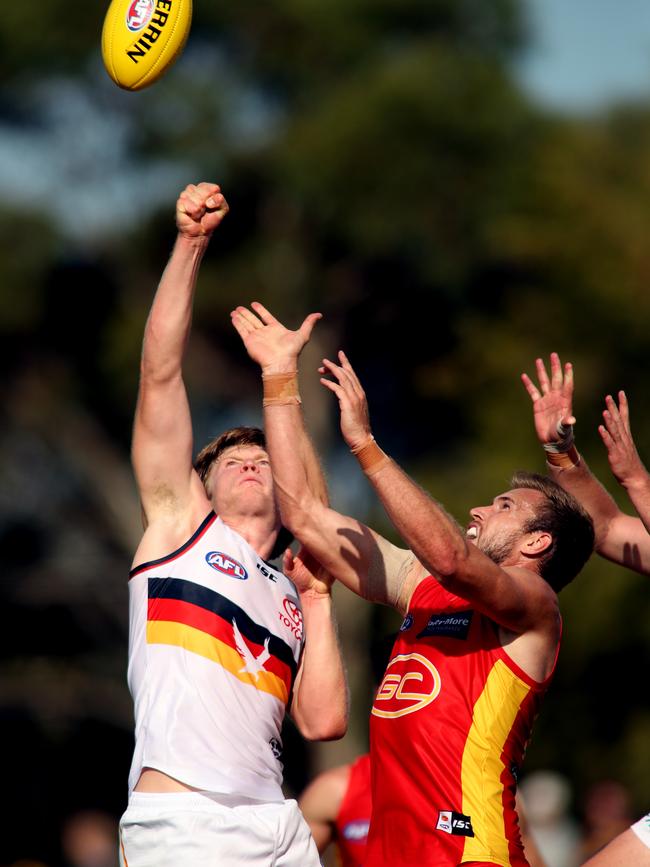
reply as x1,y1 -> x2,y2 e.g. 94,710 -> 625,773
366,577 -> 550,867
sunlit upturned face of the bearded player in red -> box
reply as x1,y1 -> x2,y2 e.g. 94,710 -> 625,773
466,488 -> 544,566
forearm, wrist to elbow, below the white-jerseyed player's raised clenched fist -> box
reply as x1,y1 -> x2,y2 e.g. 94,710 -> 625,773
142,234 -> 208,379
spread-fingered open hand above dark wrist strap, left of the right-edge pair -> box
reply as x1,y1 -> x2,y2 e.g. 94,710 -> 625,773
521,352 -> 576,445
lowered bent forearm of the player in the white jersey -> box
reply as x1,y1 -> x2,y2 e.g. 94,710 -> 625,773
292,592 -> 348,740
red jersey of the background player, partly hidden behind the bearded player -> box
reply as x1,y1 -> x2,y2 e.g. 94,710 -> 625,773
334,753 -> 372,867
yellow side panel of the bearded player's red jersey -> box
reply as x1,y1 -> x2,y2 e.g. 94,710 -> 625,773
461,659 -> 530,867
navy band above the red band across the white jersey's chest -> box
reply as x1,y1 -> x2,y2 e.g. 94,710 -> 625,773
148,578 -> 298,679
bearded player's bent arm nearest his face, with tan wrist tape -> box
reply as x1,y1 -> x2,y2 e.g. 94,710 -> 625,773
321,352 -> 557,633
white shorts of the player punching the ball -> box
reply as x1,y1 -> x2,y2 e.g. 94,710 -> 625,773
120,792 -> 320,867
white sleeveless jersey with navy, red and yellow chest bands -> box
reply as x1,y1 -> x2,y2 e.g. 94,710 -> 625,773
128,513 -> 303,800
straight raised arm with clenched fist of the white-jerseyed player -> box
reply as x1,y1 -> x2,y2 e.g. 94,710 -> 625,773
132,183 -> 228,525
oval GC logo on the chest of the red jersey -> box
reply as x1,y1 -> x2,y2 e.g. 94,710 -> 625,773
372,653 -> 441,719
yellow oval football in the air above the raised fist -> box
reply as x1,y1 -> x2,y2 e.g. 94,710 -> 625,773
102,0 -> 192,90
